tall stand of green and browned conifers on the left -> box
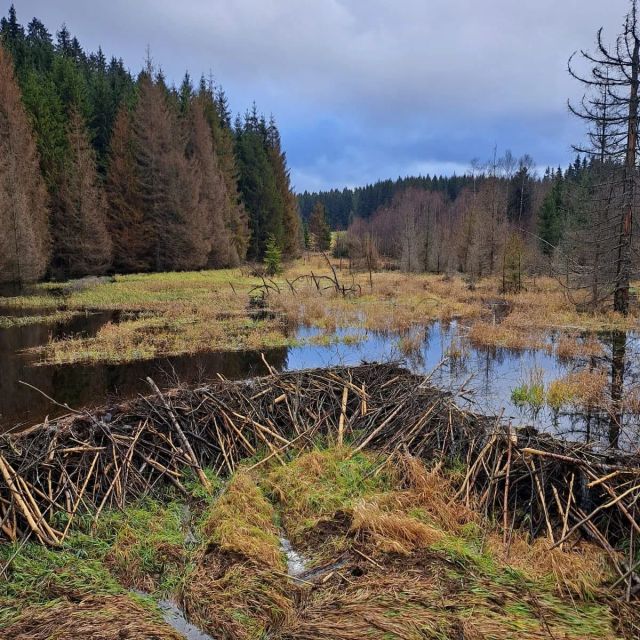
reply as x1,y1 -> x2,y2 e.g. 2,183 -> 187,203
0,6 -> 303,283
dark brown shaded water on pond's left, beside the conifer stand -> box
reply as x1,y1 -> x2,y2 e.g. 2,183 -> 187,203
0,312 -> 286,431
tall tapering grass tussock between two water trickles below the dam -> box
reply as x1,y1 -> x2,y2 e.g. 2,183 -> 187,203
182,470 -> 295,640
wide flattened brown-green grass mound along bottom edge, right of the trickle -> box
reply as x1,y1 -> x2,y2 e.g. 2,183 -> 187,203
273,552 -> 617,640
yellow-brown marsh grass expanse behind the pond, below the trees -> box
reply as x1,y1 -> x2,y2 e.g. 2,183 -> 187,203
16,255 -> 636,363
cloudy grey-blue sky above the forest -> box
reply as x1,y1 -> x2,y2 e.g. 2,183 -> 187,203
8,0 -> 628,191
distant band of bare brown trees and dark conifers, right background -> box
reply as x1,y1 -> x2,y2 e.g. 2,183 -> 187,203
324,152 -> 616,289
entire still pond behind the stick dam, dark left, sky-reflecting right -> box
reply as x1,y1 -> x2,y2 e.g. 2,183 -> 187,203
0,312 -> 640,445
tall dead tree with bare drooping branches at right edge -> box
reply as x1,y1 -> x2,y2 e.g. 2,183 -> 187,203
568,0 -> 640,314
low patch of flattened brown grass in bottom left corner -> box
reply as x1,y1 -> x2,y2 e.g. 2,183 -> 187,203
0,596 -> 184,640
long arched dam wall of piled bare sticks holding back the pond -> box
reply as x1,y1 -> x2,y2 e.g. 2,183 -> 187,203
0,365 -> 640,597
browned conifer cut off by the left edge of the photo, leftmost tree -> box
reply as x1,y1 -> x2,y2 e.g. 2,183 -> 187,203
0,46 -> 49,285
